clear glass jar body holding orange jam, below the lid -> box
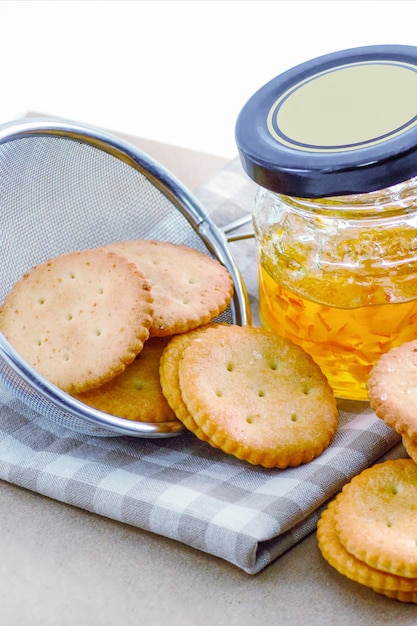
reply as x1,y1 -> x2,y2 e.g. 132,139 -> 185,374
254,177 -> 417,400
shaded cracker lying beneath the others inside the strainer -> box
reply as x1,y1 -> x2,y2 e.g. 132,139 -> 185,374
77,337 -> 175,423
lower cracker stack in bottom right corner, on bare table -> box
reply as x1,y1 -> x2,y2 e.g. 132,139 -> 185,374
317,459 -> 417,603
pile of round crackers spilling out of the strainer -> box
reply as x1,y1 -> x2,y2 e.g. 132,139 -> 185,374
0,240 -> 337,468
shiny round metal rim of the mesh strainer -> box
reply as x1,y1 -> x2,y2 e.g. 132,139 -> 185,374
0,117 -> 250,438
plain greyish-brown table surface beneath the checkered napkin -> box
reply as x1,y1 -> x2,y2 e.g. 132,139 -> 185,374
0,119 -> 417,626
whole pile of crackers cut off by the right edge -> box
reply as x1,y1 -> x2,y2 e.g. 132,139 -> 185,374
317,340 -> 417,603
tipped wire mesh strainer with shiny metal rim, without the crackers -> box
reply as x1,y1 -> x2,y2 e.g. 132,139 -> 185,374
0,118 -> 249,438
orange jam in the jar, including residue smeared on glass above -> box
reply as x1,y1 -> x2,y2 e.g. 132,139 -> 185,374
259,216 -> 417,400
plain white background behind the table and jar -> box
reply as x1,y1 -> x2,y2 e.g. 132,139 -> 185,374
0,0 -> 417,158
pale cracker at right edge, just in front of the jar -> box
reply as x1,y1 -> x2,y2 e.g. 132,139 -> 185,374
368,340 -> 417,439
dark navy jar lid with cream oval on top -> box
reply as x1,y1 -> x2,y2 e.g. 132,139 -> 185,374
236,45 -> 417,198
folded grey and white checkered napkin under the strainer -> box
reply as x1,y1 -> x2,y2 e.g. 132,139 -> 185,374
0,155 -> 405,574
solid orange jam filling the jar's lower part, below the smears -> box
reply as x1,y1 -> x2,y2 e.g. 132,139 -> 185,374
259,260 -> 417,400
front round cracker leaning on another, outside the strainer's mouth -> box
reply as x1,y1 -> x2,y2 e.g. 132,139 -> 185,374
178,325 -> 337,468
